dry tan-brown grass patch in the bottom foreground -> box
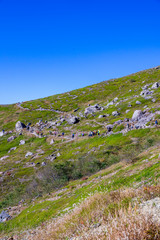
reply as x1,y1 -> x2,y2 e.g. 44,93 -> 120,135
21,186 -> 160,240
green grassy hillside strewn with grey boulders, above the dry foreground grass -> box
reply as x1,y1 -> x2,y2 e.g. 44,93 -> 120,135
0,67 -> 160,239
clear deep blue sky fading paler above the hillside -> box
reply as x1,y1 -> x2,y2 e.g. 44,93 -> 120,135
0,0 -> 160,104
